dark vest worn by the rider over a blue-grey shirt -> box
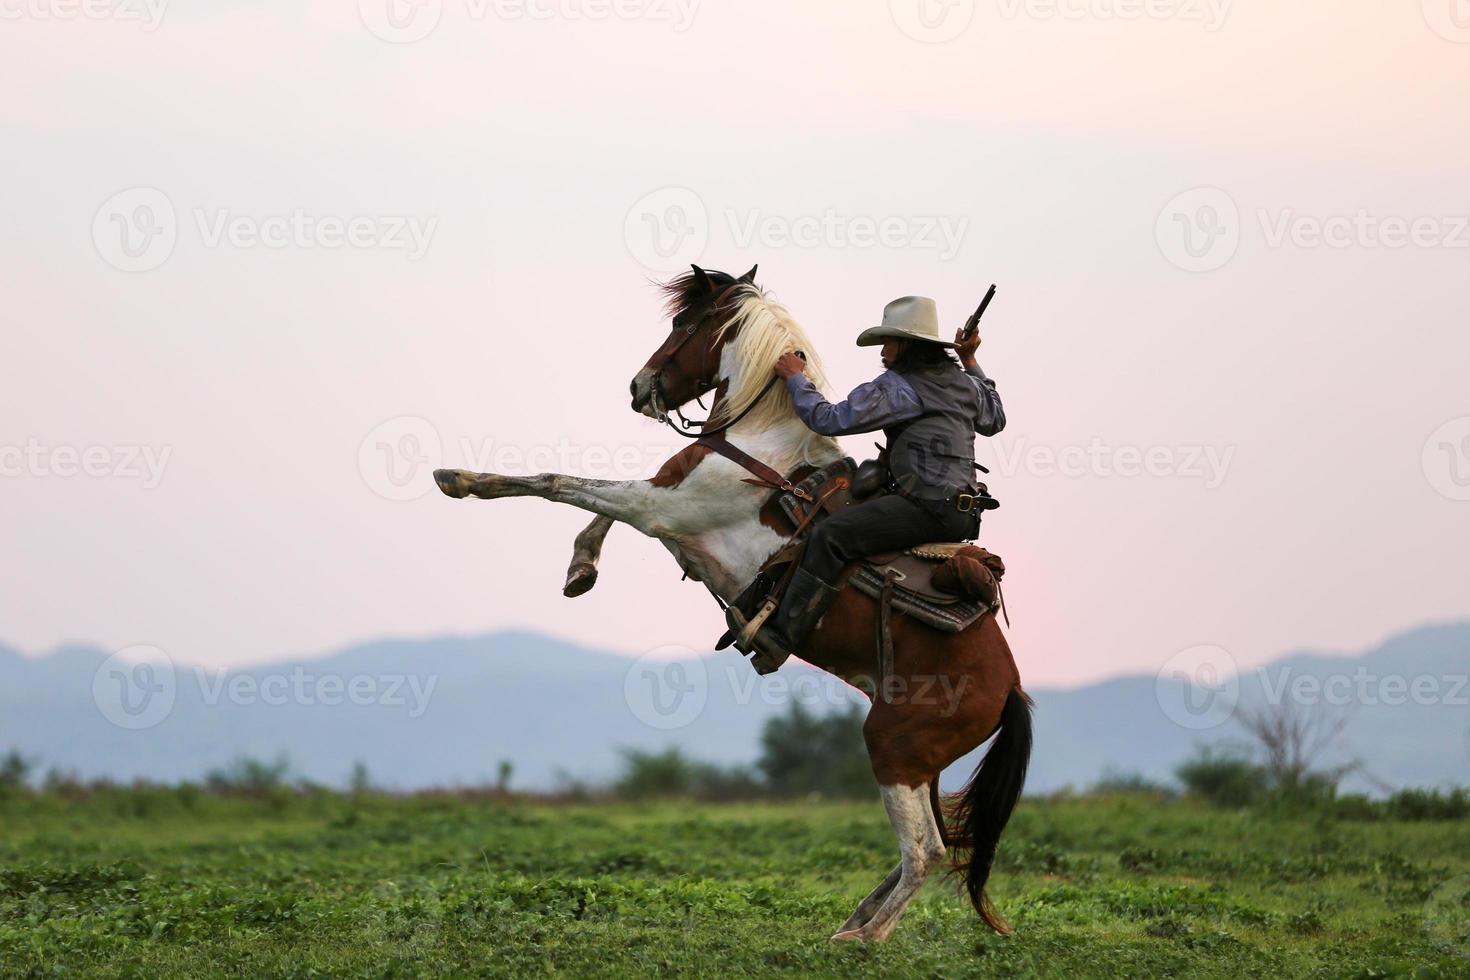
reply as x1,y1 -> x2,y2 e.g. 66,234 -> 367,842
883,363 -> 980,500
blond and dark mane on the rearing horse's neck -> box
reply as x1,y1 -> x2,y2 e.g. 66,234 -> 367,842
663,272 -> 836,455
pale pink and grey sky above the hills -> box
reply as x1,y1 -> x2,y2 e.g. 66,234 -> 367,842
0,0 -> 1470,685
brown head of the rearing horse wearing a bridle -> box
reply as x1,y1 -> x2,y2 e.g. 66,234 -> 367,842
629,266 -> 760,419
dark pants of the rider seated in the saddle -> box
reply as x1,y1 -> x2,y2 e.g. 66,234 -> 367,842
801,494 -> 979,585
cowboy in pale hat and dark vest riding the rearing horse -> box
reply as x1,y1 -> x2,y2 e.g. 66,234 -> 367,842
731,297 -> 1005,669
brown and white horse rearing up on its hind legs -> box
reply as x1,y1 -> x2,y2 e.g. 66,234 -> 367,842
434,269 -> 1030,942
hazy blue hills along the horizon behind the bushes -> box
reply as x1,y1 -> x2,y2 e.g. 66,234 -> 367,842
0,623 -> 1470,792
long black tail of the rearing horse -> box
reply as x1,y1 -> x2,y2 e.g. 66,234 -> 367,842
929,688 -> 1032,934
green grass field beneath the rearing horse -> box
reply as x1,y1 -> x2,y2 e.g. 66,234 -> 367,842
0,789 -> 1470,977
